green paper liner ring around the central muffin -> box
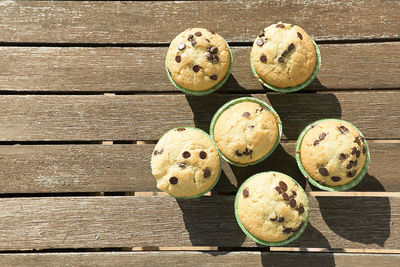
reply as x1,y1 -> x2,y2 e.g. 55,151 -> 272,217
210,97 -> 282,167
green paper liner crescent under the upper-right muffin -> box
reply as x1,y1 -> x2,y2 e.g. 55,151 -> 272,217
250,39 -> 321,93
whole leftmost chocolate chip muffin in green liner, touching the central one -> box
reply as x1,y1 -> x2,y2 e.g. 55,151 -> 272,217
151,127 -> 221,198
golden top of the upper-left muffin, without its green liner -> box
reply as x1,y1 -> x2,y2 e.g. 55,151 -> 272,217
167,28 -> 231,91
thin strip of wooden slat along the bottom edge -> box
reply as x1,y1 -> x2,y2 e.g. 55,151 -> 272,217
0,251 -> 400,267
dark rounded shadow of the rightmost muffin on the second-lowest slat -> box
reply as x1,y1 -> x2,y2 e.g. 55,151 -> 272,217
316,197 -> 391,247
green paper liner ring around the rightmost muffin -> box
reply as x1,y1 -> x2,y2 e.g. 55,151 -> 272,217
296,119 -> 370,192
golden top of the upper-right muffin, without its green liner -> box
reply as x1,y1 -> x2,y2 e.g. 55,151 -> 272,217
250,22 -> 317,88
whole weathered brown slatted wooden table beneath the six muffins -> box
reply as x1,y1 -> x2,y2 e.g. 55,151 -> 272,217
0,0 -> 400,266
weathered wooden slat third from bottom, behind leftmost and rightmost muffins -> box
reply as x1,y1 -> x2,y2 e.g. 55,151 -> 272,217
0,143 -> 400,193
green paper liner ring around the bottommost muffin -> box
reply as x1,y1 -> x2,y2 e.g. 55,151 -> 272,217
234,171 -> 310,247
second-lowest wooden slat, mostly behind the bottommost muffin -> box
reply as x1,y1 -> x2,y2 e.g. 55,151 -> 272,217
0,196 -> 400,250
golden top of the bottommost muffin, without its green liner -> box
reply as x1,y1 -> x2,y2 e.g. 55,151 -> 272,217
237,172 -> 309,242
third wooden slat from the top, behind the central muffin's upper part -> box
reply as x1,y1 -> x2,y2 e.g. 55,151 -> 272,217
0,91 -> 400,141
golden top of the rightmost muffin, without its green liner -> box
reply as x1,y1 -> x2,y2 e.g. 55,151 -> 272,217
300,120 -> 367,186
